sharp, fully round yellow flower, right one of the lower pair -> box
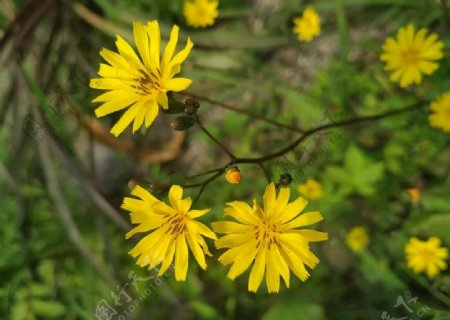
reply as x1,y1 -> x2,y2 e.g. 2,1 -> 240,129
212,183 -> 328,293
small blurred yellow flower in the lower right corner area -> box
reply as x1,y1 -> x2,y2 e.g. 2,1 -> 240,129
405,237 -> 448,278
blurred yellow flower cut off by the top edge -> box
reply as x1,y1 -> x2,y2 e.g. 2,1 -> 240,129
183,0 -> 219,28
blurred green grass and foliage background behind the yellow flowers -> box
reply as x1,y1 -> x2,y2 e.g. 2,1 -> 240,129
0,0 -> 450,320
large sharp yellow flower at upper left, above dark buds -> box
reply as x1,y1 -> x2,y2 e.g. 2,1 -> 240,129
90,21 -> 193,137
